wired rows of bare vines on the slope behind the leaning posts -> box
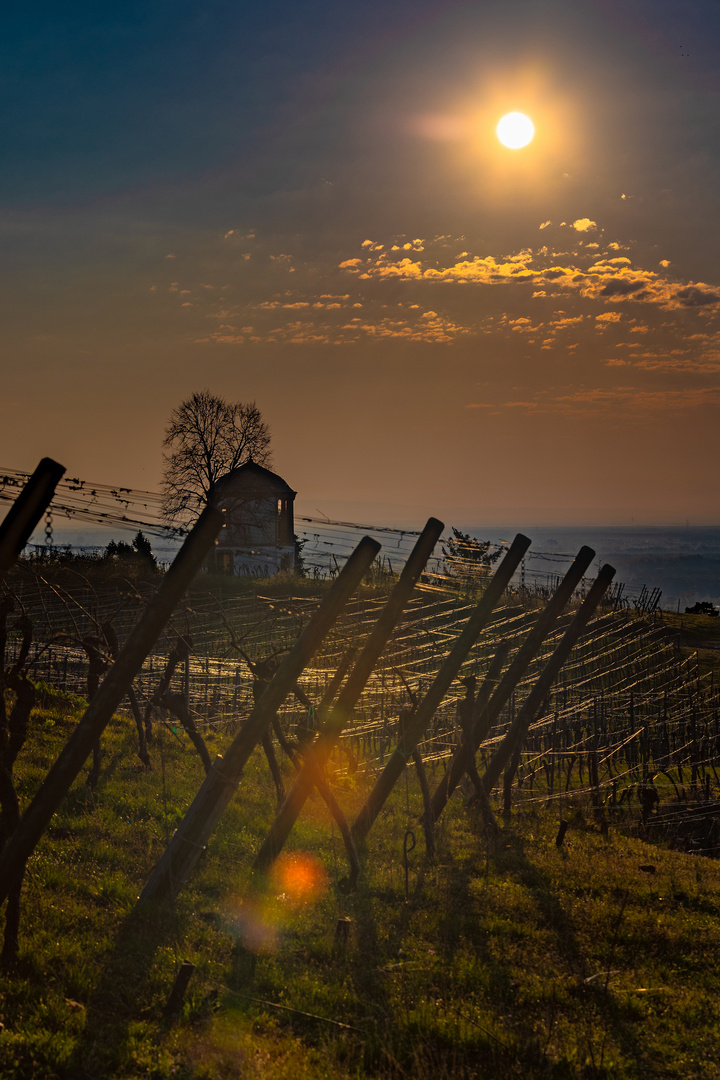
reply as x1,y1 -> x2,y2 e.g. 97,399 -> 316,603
5,552 -> 720,846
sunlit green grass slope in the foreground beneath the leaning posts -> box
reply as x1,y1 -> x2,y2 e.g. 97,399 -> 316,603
0,691 -> 720,1080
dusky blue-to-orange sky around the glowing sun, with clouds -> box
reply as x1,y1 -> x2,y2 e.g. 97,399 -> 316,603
0,0 -> 720,527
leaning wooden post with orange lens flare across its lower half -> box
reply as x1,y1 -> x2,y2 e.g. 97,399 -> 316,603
253,517 -> 445,870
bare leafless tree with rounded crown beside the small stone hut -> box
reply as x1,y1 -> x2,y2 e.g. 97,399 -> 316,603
163,390 -> 272,524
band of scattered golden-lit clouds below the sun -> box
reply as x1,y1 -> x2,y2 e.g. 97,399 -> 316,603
170,218 -> 720,371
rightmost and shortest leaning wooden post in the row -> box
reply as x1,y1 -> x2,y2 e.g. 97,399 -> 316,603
483,563 -> 615,795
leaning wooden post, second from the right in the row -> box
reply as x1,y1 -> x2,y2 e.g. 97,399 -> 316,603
433,548 -> 595,821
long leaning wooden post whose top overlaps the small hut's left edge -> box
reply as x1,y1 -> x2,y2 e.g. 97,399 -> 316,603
0,507 -> 223,902
